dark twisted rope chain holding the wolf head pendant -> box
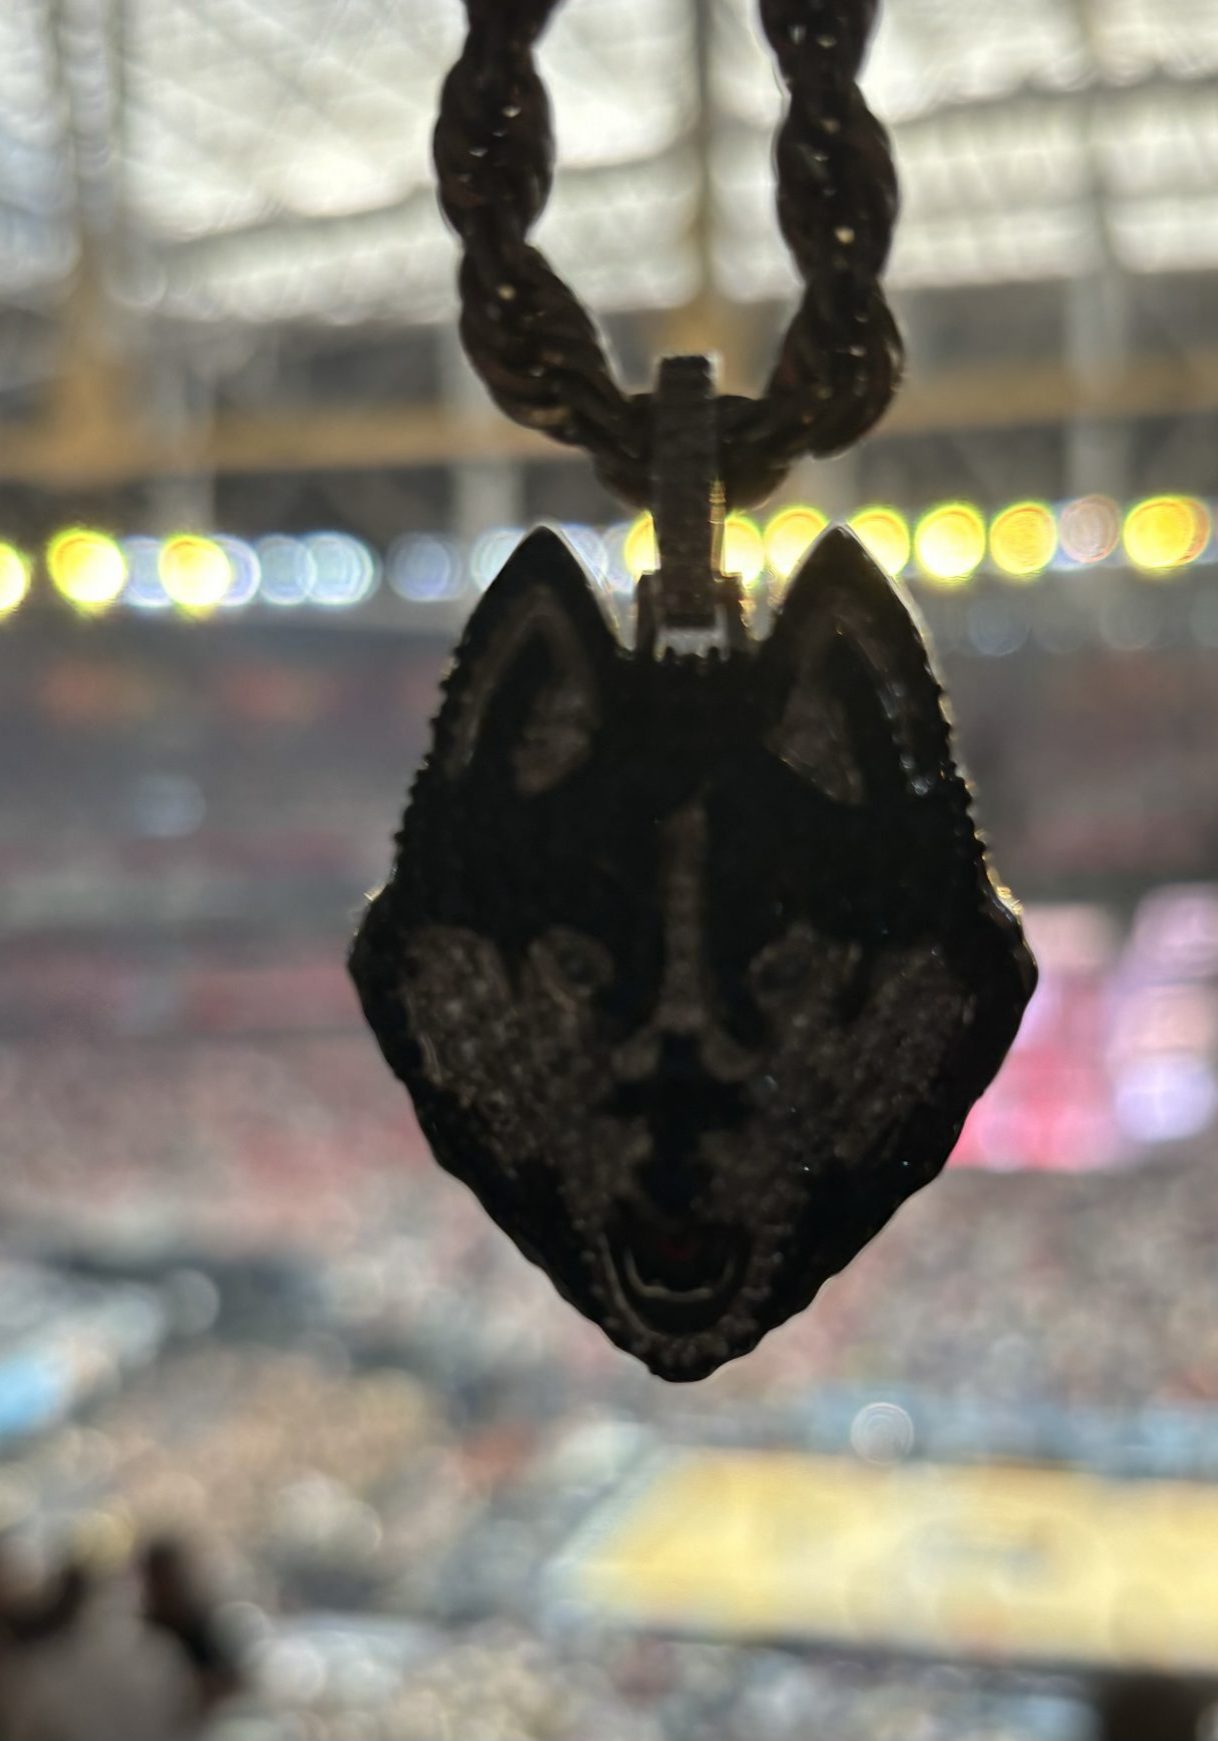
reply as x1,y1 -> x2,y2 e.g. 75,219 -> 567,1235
433,0 -> 903,505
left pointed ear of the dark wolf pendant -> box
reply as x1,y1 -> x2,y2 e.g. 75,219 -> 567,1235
435,529 -> 618,797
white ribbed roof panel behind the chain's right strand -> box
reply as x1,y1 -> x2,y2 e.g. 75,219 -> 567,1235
713,0 -> 1218,296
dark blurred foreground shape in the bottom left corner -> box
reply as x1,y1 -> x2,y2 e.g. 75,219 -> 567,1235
0,1539 -> 242,1741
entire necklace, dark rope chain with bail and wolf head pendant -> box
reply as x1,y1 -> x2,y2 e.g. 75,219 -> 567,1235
350,0 -> 1035,1379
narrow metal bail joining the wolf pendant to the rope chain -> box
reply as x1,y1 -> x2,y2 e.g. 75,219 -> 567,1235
635,357 -> 748,655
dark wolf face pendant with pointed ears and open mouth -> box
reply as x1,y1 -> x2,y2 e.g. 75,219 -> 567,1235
350,531 -> 1035,1379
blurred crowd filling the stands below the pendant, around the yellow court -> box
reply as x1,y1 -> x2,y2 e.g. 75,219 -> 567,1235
0,1036 -> 1218,1741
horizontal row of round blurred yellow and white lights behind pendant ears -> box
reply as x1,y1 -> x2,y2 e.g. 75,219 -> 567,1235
0,496 -> 1215,616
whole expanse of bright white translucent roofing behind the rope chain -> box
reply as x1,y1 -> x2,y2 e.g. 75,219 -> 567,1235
9,0 -> 1218,322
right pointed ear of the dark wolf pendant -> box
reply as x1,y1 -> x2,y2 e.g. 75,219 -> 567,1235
759,526 -> 957,804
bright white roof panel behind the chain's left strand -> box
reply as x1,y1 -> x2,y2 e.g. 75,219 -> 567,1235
125,0 -> 696,320
